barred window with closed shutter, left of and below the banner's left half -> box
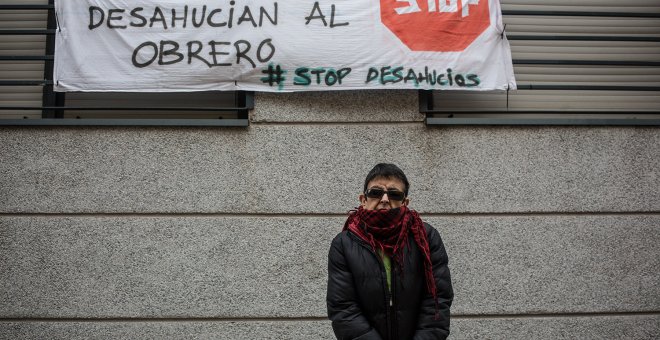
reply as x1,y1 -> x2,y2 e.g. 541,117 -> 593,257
0,0 -> 252,126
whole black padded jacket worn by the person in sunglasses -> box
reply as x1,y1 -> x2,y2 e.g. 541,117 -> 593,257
327,223 -> 454,340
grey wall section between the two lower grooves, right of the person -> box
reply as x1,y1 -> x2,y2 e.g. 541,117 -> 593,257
428,215 -> 660,314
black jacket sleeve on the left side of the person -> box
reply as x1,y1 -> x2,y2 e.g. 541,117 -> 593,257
326,233 -> 381,340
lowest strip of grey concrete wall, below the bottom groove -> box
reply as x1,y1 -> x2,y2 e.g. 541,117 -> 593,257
0,315 -> 660,340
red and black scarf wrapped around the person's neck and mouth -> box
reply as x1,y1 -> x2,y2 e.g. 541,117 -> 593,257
343,206 -> 438,317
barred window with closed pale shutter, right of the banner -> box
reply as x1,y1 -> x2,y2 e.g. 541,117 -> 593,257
420,0 -> 660,119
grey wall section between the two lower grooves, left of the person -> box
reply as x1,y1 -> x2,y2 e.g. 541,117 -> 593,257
0,217 -> 331,318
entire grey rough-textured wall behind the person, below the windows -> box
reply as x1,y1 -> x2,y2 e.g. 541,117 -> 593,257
0,91 -> 660,339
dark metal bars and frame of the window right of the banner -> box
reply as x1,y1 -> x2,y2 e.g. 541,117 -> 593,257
418,10 -> 660,126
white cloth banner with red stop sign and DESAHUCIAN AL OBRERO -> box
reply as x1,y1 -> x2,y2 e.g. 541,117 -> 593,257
54,0 -> 516,92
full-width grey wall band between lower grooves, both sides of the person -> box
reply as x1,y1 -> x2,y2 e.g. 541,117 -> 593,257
0,215 -> 660,318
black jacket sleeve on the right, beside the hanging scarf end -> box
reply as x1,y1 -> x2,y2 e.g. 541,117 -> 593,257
414,224 -> 454,340
